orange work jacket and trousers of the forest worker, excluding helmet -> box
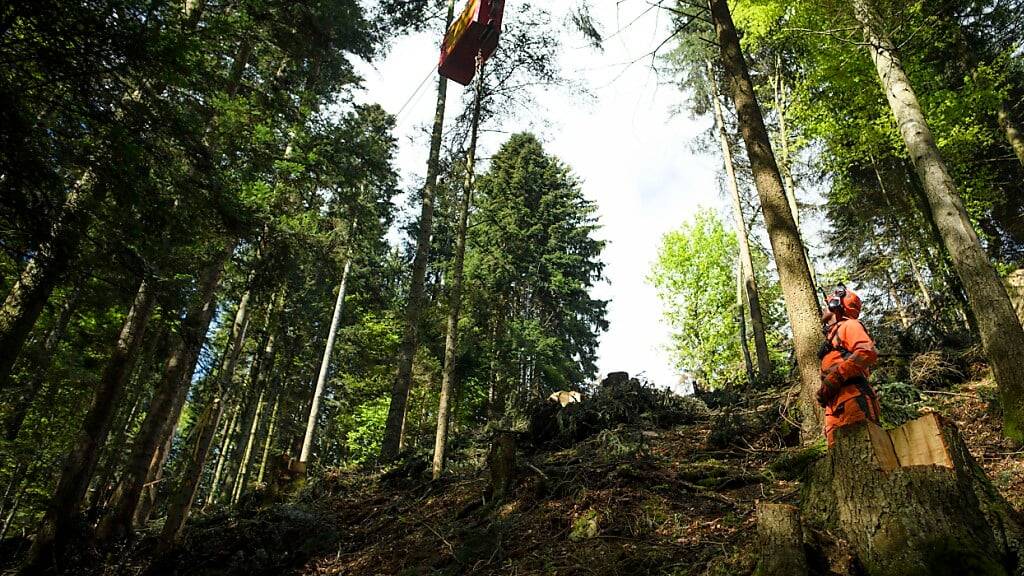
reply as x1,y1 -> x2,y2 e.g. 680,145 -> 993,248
821,318 -> 880,446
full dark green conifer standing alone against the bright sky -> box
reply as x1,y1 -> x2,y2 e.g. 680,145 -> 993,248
466,133 -> 607,414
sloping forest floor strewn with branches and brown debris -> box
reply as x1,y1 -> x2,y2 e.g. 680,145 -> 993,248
48,368 -> 1024,576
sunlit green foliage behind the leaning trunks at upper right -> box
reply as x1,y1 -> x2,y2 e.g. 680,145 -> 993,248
667,0 -> 1024,358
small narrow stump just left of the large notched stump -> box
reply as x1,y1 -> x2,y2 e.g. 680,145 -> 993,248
755,502 -> 808,576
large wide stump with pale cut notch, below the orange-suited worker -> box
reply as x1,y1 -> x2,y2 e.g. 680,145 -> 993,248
803,414 -> 1024,576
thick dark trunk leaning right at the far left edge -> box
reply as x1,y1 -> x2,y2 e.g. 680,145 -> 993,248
0,177 -> 102,390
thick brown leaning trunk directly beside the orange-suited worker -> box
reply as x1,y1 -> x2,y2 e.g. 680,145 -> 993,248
710,0 -> 823,434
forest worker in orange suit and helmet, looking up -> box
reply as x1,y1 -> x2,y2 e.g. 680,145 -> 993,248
818,284 -> 880,447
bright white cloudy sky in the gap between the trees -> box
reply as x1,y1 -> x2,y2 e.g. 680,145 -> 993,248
358,0 -> 728,386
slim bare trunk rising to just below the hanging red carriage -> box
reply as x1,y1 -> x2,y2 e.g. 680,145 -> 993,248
432,57 -> 483,480
